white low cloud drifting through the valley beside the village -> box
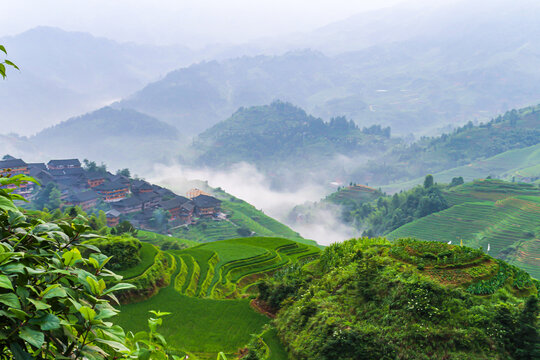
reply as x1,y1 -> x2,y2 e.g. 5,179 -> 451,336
148,163 -> 355,245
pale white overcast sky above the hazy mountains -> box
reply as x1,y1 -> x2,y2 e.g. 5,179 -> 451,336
0,0 -> 413,46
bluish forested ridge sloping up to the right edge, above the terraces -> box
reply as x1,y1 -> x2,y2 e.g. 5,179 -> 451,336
350,106 -> 540,187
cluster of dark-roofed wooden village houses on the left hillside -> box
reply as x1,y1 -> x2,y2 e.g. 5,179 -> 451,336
0,158 -> 221,228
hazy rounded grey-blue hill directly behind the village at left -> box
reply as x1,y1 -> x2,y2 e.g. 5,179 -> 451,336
28,107 -> 183,171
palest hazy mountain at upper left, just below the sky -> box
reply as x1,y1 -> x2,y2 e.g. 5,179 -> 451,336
0,27 -> 194,135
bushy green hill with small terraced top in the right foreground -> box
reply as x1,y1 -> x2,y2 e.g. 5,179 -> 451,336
266,238 -> 540,360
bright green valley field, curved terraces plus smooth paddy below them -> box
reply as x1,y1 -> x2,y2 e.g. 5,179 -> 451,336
115,237 -> 320,360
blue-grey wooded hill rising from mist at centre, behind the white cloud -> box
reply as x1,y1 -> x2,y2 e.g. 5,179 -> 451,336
193,101 -> 399,187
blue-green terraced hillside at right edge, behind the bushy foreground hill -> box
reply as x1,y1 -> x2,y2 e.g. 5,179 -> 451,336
388,180 -> 540,279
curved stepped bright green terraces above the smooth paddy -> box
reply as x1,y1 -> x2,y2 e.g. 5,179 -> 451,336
174,237 -> 320,299
